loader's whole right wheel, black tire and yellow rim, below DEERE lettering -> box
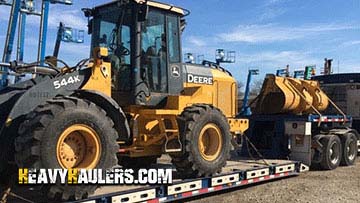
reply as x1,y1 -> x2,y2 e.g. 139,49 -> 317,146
171,105 -> 231,178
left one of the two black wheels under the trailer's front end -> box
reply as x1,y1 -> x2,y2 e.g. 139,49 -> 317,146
320,135 -> 342,170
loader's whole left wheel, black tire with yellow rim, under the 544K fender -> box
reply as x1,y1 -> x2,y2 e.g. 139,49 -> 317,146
15,97 -> 119,200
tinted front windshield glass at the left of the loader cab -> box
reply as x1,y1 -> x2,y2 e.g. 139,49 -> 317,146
92,6 -> 132,91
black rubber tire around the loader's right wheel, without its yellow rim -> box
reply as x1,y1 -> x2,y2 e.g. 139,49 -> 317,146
170,105 -> 231,178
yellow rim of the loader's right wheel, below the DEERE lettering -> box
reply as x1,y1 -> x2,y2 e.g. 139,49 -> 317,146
198,123 -> 223,161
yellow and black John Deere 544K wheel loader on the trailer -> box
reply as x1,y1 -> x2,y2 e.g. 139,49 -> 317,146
0,0 -> 248,199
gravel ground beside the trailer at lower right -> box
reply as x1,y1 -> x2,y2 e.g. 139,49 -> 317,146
188,160 -> 360,203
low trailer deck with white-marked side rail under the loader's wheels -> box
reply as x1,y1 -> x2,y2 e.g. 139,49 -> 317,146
78,160 -> 309,203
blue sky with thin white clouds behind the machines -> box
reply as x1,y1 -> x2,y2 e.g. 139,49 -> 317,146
0,0 -> 360,81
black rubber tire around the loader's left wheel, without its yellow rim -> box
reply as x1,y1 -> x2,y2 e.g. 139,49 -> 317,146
15,97 -> 119,200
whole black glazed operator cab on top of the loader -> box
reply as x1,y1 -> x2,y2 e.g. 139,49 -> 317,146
89,1 -> 183,106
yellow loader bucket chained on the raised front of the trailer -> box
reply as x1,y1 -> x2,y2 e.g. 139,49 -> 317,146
254,74 -> 329,114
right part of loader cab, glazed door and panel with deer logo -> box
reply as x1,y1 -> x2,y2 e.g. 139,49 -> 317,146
141,8 -> 182,106
